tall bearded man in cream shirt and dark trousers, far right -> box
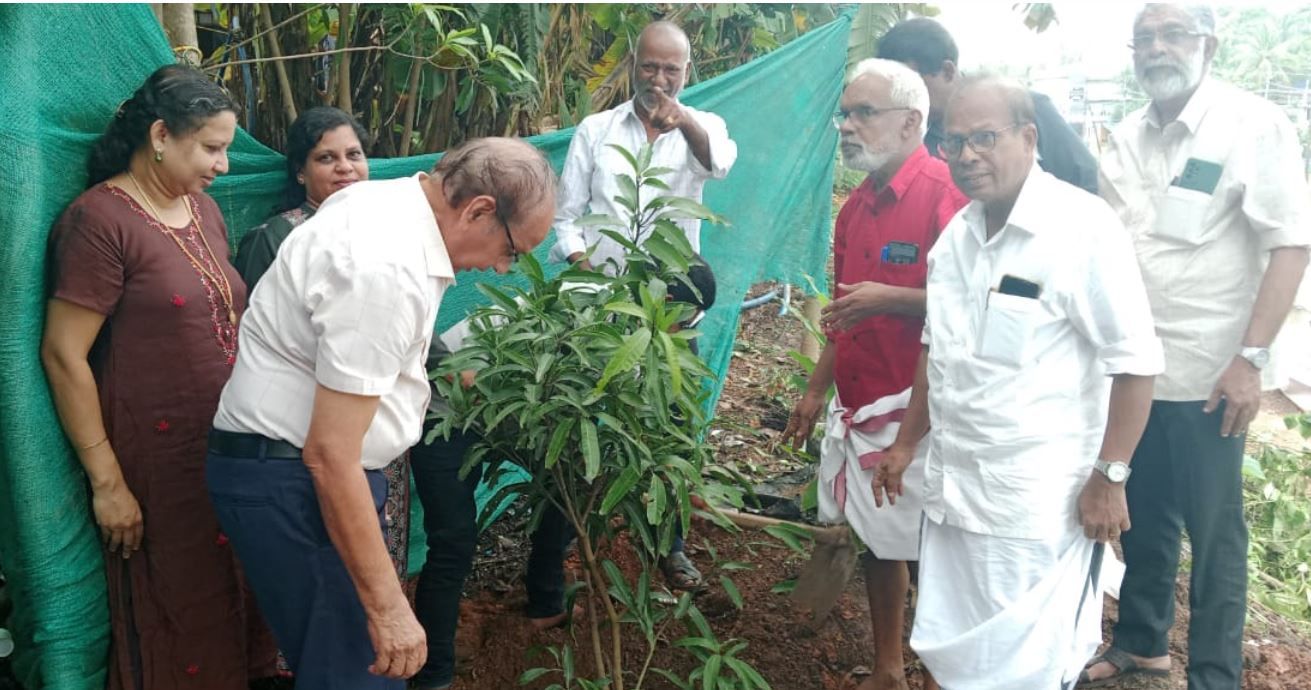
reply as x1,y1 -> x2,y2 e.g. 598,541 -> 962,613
1080,5 -> 1311,690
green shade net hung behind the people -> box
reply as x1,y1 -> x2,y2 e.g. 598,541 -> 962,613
0,5 -> 851,690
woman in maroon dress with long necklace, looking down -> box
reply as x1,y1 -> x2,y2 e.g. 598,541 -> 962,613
42,66 -> 275,690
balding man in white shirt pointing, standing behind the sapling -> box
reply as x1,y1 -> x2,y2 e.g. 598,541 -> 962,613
552,21 -> 737,274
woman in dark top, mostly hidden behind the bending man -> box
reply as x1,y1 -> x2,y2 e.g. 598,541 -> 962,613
233,106 -> 409,582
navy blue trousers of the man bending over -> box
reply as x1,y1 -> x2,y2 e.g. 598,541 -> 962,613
203,451 -> 405,690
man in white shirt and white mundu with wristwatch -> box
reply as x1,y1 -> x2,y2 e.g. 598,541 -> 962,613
873,77 -> 1163,690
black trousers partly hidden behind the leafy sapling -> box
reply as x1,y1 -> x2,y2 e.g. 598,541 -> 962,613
410,432 -> 574,687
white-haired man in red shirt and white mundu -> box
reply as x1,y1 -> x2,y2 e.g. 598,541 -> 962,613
783,59 -> 968,690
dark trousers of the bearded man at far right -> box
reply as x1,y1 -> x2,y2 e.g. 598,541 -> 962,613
1114,400 -> 1247,690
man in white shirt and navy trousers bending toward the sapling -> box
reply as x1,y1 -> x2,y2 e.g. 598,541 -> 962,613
206,139 -> 555,690
